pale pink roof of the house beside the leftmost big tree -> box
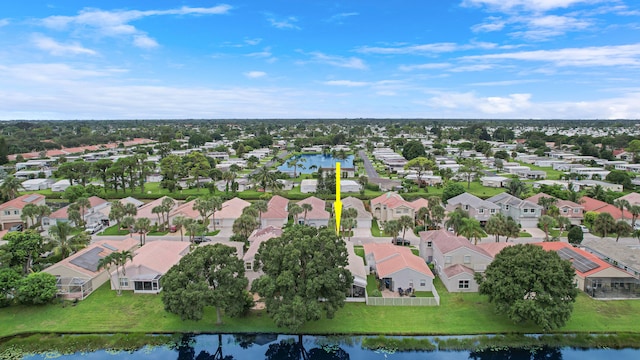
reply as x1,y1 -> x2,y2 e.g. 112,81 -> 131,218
126,240 -> 191,278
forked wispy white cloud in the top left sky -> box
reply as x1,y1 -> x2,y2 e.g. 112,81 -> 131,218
40,5 -> 231,48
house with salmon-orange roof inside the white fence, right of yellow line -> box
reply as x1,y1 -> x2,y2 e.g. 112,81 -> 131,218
364,243 -> 435,291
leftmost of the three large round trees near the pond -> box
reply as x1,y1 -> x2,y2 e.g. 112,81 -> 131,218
161,244 -> 252,324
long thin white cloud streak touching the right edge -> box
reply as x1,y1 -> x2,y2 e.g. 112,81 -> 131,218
460,43 -> 640,67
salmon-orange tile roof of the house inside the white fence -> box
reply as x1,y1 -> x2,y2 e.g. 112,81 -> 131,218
364,243 -> 434,279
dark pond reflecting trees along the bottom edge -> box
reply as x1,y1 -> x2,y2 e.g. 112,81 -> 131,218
17,334 -> 640,360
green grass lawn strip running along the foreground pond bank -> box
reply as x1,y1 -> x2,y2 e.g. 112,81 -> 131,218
0,280 -> 640,337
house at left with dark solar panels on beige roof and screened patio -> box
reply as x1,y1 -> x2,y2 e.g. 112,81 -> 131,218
42,238 -> 138,300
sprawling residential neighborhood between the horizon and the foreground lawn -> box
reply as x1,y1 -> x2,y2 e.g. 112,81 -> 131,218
0,120 -> 640,330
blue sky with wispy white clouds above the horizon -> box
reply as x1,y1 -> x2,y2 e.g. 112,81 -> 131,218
0,0 -> 640,119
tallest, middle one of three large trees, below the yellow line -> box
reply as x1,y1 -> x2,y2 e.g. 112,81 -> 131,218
252,225 -> 353,331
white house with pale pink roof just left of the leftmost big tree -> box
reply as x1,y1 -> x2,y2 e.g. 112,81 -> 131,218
111,240 -> 191,294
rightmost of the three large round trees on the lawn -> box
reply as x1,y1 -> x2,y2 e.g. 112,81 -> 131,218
475,244 -> 578,331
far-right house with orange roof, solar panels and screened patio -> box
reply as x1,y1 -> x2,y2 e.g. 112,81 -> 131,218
535,241 -> 640,299
